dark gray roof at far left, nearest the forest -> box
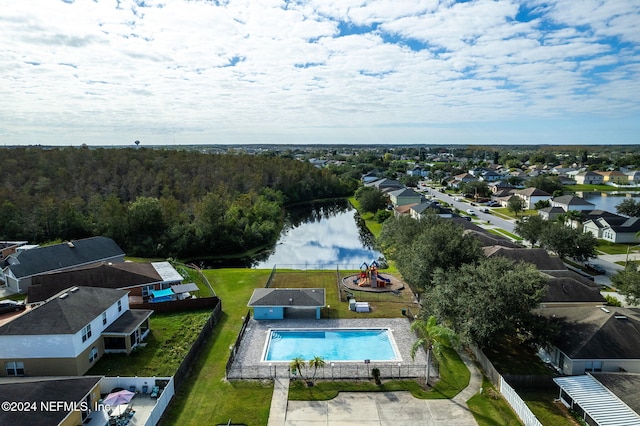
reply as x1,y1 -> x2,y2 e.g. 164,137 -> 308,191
11,237 -> 124,278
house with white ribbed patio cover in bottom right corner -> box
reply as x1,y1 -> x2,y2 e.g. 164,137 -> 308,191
553,373 -> 640,426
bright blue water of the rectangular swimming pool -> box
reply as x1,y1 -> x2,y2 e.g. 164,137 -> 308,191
263,329 -> 400,361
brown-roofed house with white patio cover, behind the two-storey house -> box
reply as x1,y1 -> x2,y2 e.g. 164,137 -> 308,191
27,262 -> 183,303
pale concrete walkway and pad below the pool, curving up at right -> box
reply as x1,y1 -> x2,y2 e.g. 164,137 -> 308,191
269,353 -> 482,426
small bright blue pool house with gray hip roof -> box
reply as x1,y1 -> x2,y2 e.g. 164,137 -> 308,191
247,288 -> 326,320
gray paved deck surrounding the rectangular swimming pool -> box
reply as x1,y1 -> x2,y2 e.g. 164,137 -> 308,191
227,318 -> 428,379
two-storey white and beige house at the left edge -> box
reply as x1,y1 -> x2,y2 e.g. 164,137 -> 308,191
0,287 -> 153,376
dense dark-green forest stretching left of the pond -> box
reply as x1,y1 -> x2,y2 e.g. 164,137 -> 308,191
0,147 -> 357,258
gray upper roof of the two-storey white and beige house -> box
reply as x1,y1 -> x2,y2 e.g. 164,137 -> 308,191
0,287 -> 128,335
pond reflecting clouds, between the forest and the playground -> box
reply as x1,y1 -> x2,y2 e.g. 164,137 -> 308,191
252,201 -> 381,269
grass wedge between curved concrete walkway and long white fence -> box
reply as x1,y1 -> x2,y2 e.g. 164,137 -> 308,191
467,377 -> 524,426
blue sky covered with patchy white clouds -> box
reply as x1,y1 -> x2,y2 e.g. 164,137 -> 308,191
0,0 -> 640,146
